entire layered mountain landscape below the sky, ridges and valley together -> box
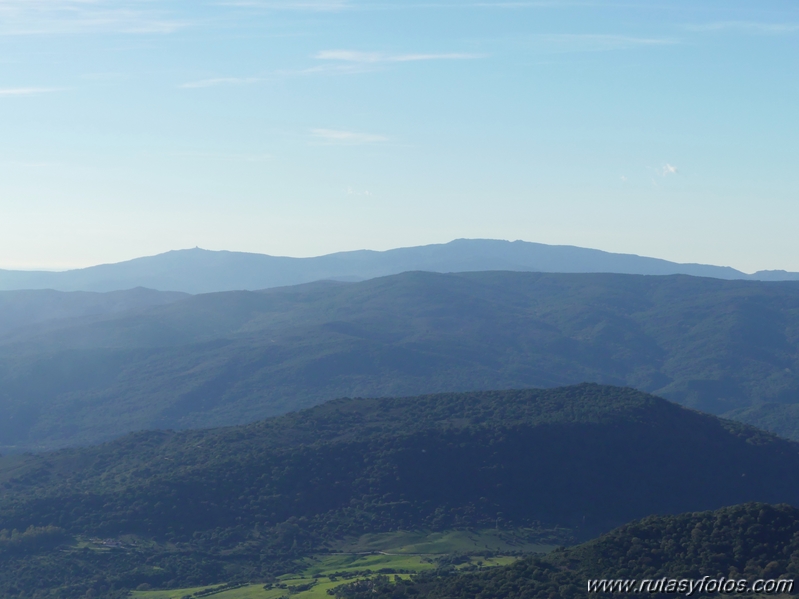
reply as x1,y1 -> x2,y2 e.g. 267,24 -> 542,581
0,240 -> 799,599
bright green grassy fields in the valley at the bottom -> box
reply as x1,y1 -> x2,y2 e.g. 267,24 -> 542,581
131,553 -> 517,599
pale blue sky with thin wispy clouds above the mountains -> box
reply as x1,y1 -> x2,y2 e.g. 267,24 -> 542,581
0,0 -> 799,272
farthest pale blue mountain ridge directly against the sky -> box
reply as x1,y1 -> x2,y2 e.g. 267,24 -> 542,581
0,239 -> 799,293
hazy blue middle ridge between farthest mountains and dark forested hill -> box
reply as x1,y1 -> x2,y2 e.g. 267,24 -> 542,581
0,272 -> 799,451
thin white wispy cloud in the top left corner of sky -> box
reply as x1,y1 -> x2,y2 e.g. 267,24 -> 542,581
0,0 -> 187,35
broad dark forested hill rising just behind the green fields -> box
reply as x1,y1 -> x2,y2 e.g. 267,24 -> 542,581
0,384 -> 799,596
